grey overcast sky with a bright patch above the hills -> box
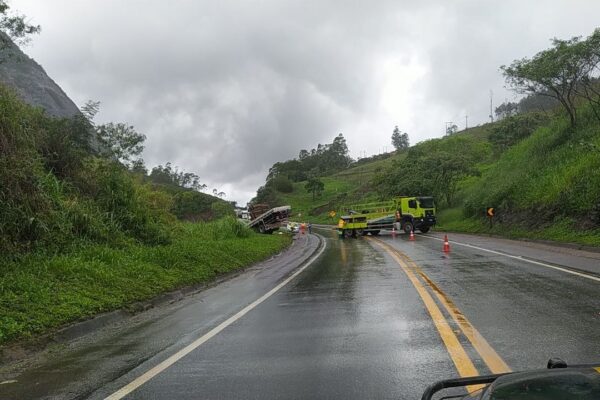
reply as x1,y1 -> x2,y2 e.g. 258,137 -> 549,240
16,0 -> 600,204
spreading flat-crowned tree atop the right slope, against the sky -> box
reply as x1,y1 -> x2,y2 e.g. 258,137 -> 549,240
500,30 -> 600,126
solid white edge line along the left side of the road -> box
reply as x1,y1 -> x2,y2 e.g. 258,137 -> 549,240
105,234 -> 327,400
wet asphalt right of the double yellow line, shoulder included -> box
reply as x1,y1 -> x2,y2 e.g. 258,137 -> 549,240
394,234 -> 600,370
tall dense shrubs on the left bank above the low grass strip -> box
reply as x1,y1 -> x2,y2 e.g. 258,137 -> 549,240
0,85 -> 174,258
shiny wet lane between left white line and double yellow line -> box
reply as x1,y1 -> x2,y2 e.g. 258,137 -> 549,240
112,232 -> 454,399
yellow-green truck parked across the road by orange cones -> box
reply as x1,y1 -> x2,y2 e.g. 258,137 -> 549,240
338,196 -> 436,237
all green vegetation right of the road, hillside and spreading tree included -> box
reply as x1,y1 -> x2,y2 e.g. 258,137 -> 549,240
255,30 -> 600,246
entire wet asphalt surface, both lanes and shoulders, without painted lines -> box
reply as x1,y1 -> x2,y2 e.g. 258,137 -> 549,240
0,230 -> 600,399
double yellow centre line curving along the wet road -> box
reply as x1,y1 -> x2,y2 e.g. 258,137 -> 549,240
368,238 -> 511,392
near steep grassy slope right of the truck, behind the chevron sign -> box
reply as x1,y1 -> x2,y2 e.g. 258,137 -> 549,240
440,108 -> 600,245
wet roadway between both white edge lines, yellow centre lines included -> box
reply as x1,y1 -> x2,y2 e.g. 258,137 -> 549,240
101,232 -> 600,399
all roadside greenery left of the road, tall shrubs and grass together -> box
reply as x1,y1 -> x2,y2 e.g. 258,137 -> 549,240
0,86 -> 291,344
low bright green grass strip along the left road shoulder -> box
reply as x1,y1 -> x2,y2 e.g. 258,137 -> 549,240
0,218 -> 291,344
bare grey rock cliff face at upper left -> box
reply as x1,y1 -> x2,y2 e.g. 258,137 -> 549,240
0,32 -> 79,117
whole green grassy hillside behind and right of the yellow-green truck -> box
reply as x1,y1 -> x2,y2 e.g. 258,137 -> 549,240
268,106 -> 600,245
